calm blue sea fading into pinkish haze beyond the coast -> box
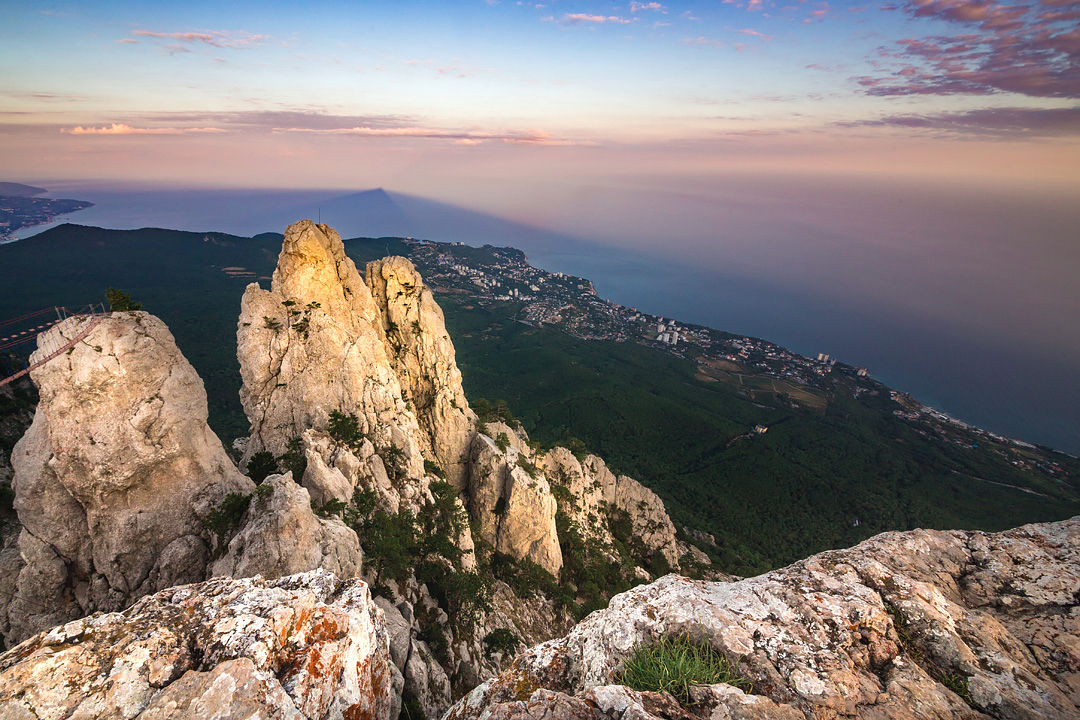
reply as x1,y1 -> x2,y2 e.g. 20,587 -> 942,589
10,178 -> 1080,454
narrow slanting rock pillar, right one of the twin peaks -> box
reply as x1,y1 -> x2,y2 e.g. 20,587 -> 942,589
365,257 -> 476,489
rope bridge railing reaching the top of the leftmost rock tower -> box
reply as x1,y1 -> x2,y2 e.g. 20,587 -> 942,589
0,304 -> 109,388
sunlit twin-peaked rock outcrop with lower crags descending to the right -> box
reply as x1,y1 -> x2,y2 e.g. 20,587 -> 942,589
238,220 -> 679,576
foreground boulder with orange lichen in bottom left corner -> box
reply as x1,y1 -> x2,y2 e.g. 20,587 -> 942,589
0,572 -> 391,720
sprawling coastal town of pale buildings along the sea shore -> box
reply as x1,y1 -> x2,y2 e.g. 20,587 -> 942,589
406,237 -> 1064,476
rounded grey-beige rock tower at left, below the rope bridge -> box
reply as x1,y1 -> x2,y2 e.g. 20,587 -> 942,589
6,312 -> 254,639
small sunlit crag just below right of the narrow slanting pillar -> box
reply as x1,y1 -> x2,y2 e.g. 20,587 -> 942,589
469,434 -> 563,576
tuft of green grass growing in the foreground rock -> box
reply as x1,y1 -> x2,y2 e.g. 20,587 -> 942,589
619,635 -> 751,706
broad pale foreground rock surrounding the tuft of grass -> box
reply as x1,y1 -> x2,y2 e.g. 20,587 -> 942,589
447,517 -> 1080,720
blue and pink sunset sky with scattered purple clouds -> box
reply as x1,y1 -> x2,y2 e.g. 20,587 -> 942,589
0,0 -> 1080,197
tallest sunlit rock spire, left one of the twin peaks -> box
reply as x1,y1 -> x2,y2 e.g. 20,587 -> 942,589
237,220 -> 424,487
